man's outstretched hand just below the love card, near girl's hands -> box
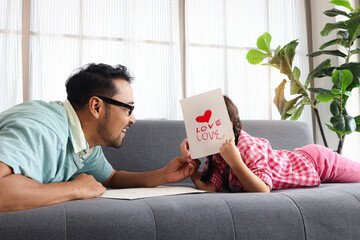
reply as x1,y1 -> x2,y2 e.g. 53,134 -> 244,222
163,156 -> 196,183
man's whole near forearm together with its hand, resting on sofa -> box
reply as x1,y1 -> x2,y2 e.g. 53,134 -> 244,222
0,173 -> 106,212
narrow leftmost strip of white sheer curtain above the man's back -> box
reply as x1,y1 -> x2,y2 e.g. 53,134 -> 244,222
0,0 -> 23,112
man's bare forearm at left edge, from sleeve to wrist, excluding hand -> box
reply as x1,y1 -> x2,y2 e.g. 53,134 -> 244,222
0,174 -> 78,212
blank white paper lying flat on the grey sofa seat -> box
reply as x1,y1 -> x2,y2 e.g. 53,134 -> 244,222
101,186 -> 206,200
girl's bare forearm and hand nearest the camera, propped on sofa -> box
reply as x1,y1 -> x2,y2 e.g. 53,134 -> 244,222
220,139 -> 271,193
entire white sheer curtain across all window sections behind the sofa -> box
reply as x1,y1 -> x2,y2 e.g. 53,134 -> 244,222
0,0 -> 311,125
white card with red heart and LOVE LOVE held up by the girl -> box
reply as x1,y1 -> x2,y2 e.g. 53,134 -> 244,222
180,88 -> 234,159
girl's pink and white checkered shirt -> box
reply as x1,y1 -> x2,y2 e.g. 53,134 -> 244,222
204,130 -> 320,191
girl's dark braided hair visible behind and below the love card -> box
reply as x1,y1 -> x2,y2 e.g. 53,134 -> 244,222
201,95 -> 242,192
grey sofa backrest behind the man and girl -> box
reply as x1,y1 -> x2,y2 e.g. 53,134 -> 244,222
103,120 -> 313,178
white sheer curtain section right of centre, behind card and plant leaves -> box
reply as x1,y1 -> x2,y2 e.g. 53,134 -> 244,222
185,0 -> 311,127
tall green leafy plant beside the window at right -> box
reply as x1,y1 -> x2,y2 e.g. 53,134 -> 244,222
246,0 -> 360,153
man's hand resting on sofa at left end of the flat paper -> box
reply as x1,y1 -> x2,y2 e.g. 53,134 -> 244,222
72,173 -> 106,199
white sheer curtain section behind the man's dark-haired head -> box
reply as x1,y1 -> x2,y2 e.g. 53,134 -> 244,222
30,0 -> 181,119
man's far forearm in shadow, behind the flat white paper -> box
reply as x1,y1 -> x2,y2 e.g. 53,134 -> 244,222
109,168 -> 167,188
